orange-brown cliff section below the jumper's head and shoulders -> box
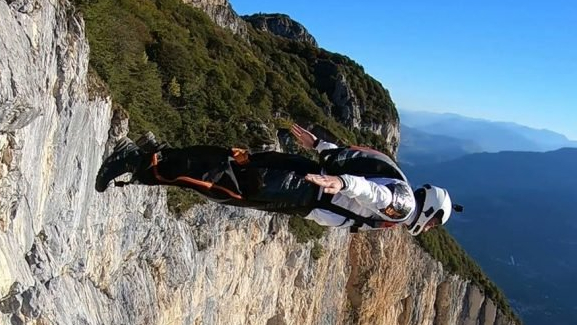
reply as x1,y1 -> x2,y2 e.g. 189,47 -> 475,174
347,231 -> 511,325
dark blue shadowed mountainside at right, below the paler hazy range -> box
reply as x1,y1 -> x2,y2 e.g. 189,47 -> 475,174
404,148 -> 577,325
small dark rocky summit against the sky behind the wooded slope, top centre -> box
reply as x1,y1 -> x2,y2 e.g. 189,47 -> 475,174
242,14 -> 318,47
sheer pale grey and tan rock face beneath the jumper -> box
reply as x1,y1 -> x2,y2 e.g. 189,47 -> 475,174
0,0 -> 504,325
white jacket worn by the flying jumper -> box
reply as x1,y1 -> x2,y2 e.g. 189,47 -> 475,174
305,140 -> 415,230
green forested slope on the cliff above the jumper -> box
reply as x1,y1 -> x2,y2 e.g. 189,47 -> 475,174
81,0 -> 397,147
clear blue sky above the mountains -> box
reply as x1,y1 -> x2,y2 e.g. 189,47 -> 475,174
230,0 -> 577,140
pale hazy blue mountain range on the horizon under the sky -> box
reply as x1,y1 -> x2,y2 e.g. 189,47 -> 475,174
399,110 -> 577,164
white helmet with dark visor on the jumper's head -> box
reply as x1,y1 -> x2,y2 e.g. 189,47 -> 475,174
408,184 -> 453,236
